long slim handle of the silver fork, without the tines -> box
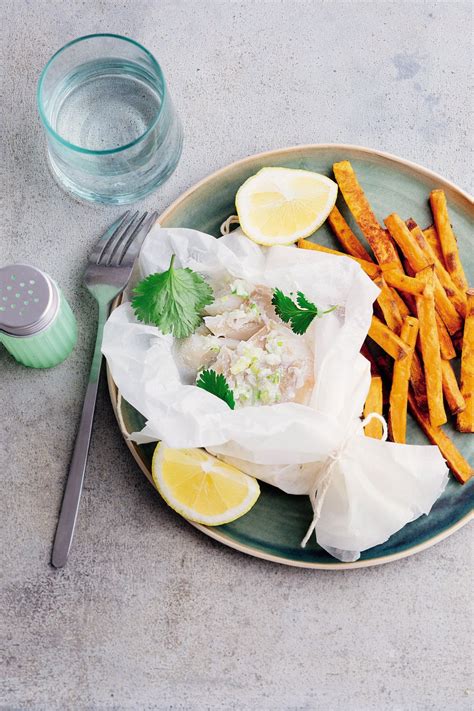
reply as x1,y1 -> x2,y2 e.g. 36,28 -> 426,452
51,302 -> 110,568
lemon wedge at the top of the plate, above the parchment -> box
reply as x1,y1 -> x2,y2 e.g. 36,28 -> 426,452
235,168 -> 337,246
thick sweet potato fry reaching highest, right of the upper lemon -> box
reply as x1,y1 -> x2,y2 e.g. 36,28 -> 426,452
333,160 -> 402,270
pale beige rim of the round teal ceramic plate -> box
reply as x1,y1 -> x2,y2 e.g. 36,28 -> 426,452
106,143 -> 474,571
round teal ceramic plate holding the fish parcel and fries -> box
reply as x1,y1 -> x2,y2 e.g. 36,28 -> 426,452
105,145 -> 474,570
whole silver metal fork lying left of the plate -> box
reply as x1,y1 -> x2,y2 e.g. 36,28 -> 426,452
51,211 -> 157,568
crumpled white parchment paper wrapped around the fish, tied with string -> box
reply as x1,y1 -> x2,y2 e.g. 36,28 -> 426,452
102,226 -> 448,560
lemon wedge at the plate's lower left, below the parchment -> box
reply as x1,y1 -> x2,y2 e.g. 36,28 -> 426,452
151,442 -> 260,526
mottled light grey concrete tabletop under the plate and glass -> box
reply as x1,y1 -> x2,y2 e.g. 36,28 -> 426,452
0,0 -> 474,711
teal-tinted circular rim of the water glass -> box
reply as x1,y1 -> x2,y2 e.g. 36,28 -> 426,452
36,32 -> 167,155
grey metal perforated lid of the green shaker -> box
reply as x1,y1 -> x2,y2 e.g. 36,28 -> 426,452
0,264 -> 59,336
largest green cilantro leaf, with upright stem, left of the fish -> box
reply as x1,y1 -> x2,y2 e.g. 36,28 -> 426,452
132,254 -> 214,338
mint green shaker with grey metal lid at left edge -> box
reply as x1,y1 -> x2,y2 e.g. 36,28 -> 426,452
0,264 -> 77,368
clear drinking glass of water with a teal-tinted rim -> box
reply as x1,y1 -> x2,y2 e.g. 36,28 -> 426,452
37,34 -> 183,204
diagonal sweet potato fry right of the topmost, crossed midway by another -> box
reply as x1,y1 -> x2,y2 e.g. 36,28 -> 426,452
385,213 -> 462,335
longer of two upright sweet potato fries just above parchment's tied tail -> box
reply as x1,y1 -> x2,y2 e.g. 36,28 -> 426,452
388,316 -> 418,443
